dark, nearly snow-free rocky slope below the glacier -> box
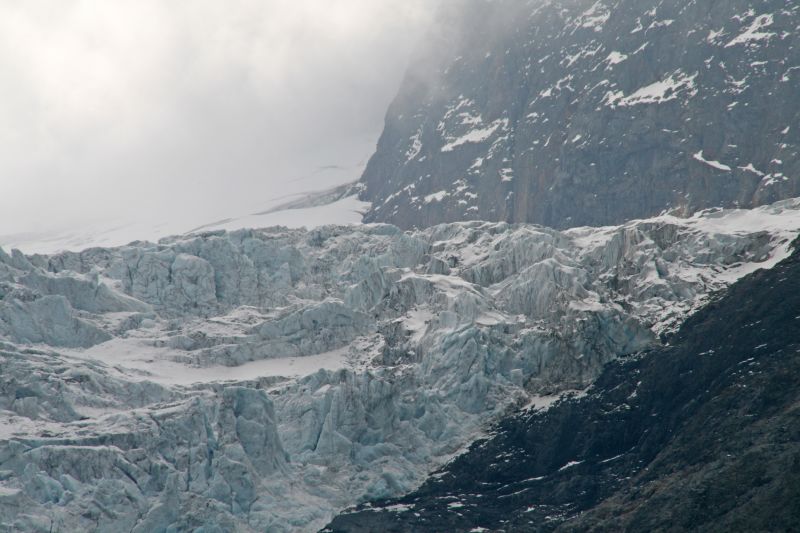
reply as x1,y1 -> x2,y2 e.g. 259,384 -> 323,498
327,238 -> 800,532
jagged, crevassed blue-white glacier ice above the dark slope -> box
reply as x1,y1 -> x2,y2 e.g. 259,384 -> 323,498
0,200 -> 800,532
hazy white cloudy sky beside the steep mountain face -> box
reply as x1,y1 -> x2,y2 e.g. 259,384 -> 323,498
0,0 -> 435,235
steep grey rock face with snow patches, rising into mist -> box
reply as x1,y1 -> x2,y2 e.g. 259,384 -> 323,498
362,0 -> 800,228
